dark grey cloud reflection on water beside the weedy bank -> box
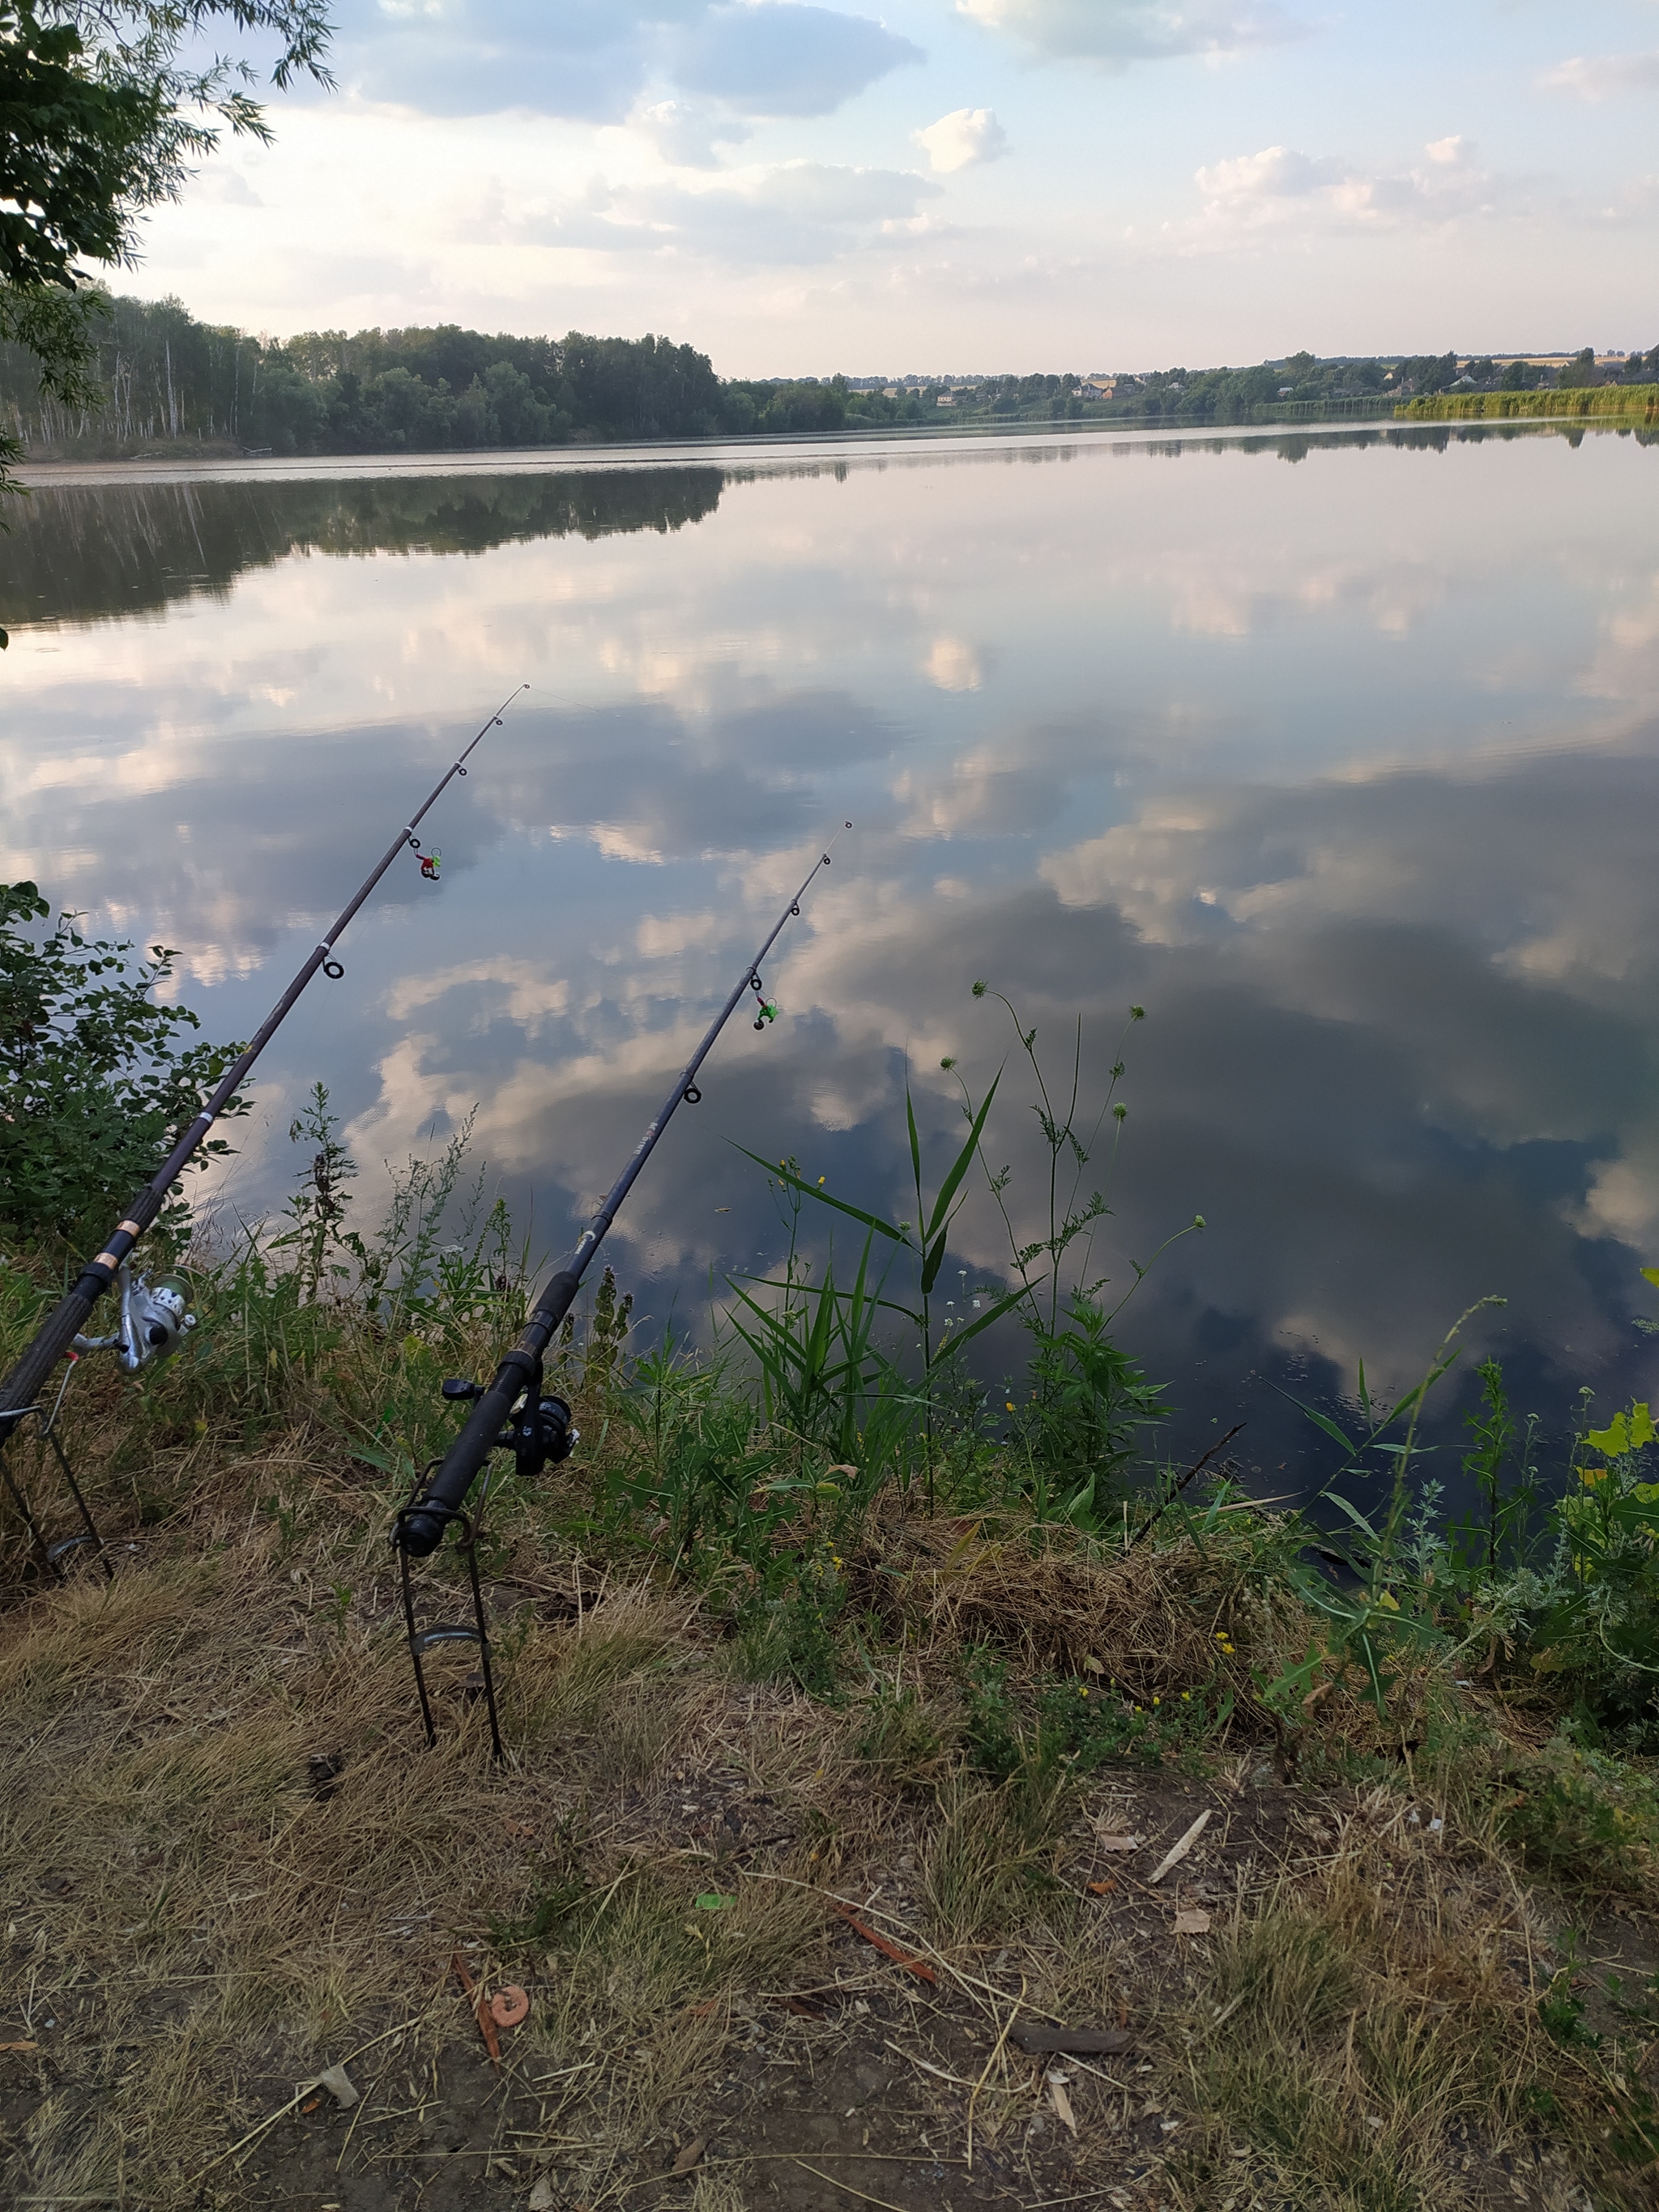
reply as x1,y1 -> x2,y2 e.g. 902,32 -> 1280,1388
338,725 -> 1659,1389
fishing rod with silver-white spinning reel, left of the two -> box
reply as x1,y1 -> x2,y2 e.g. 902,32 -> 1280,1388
0,684 -> 529,1486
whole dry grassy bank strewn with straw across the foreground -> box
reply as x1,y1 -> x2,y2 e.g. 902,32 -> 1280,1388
0,1389 -> 1653,2212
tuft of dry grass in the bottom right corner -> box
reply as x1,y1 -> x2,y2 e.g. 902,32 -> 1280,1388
1166,1798 -> 1655,2212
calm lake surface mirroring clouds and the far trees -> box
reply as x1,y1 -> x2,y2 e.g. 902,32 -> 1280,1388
0,427 -> 1659,1491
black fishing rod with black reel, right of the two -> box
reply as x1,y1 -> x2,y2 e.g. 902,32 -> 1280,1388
391,823 -> 851,1566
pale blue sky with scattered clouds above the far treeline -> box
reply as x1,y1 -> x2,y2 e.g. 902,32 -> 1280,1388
124,0 -> 1659,376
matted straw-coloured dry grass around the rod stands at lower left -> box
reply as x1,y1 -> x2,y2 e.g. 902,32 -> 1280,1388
0,1468 -> 831,2206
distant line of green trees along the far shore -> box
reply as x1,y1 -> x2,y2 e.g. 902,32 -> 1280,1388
0,299 -> 1659,454
